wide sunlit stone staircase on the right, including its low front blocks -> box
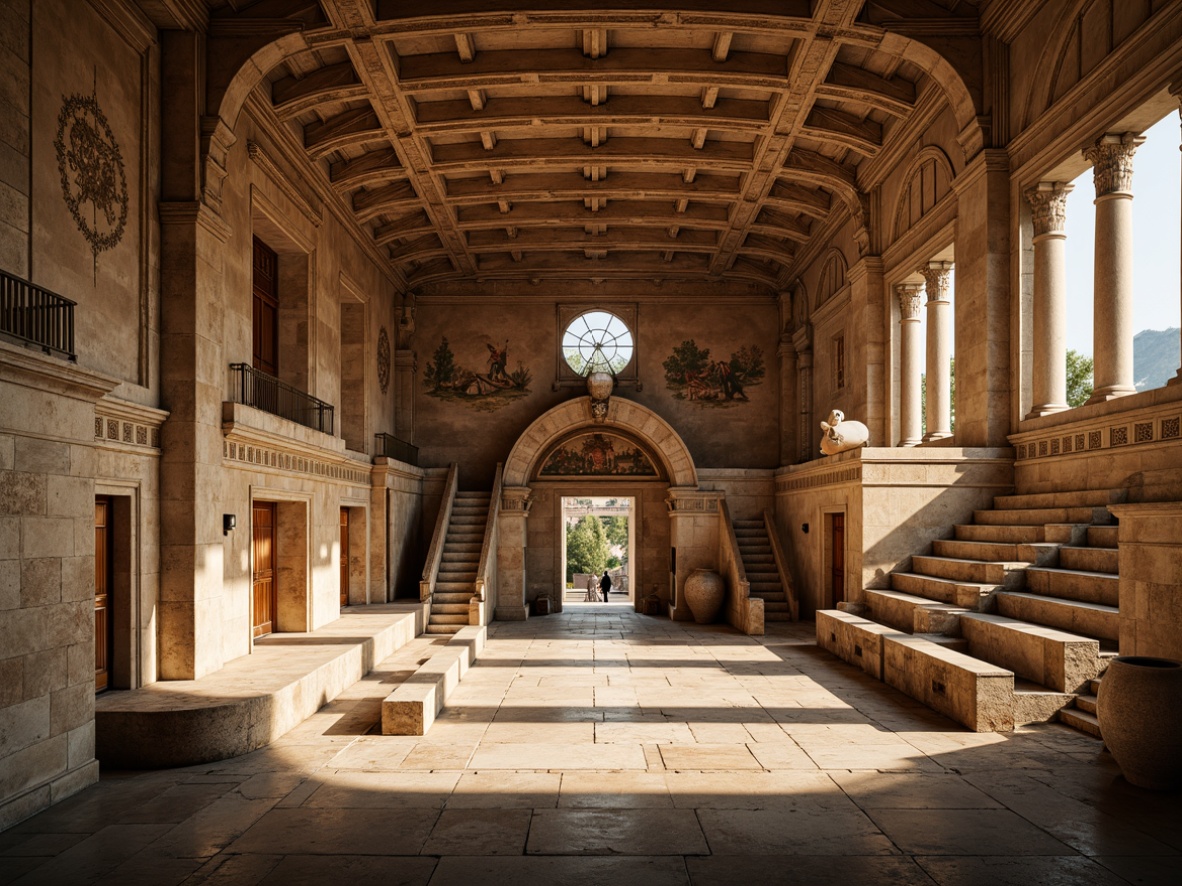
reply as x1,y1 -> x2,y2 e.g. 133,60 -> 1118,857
817,490 -> 1119,732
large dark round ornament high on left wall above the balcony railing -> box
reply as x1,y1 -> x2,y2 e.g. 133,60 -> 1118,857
53,95 -> 130,256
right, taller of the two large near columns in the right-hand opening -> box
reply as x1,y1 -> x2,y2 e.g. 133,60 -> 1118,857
1084,132 -> 1145,403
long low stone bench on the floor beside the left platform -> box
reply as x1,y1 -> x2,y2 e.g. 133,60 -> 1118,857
382,625 -> 488,735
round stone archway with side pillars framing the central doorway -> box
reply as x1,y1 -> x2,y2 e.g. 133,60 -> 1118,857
494,397 -> 722,620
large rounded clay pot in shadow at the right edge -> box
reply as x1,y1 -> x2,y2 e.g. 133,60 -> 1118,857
1096,656 -> 1182,790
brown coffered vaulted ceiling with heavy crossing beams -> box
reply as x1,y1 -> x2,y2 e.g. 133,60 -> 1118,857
200,0 -> 978,295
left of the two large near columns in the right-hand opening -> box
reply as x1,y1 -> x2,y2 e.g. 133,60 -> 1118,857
1026,182 -> 1074,418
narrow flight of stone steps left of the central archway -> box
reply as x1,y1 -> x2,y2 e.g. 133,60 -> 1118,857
427,493 -> 491,633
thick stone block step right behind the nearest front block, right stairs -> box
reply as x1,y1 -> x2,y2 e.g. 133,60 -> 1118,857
960,612 -> 1100,706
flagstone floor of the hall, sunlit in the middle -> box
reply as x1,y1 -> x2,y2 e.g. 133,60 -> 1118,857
0,602 -> 1182,886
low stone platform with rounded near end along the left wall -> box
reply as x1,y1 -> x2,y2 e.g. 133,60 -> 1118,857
95,602 -> 424,769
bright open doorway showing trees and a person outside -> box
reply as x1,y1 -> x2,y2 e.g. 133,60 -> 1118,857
561,495 -> 636,605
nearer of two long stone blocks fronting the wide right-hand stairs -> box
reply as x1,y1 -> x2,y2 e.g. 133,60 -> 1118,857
883,633 -> 1014,732
